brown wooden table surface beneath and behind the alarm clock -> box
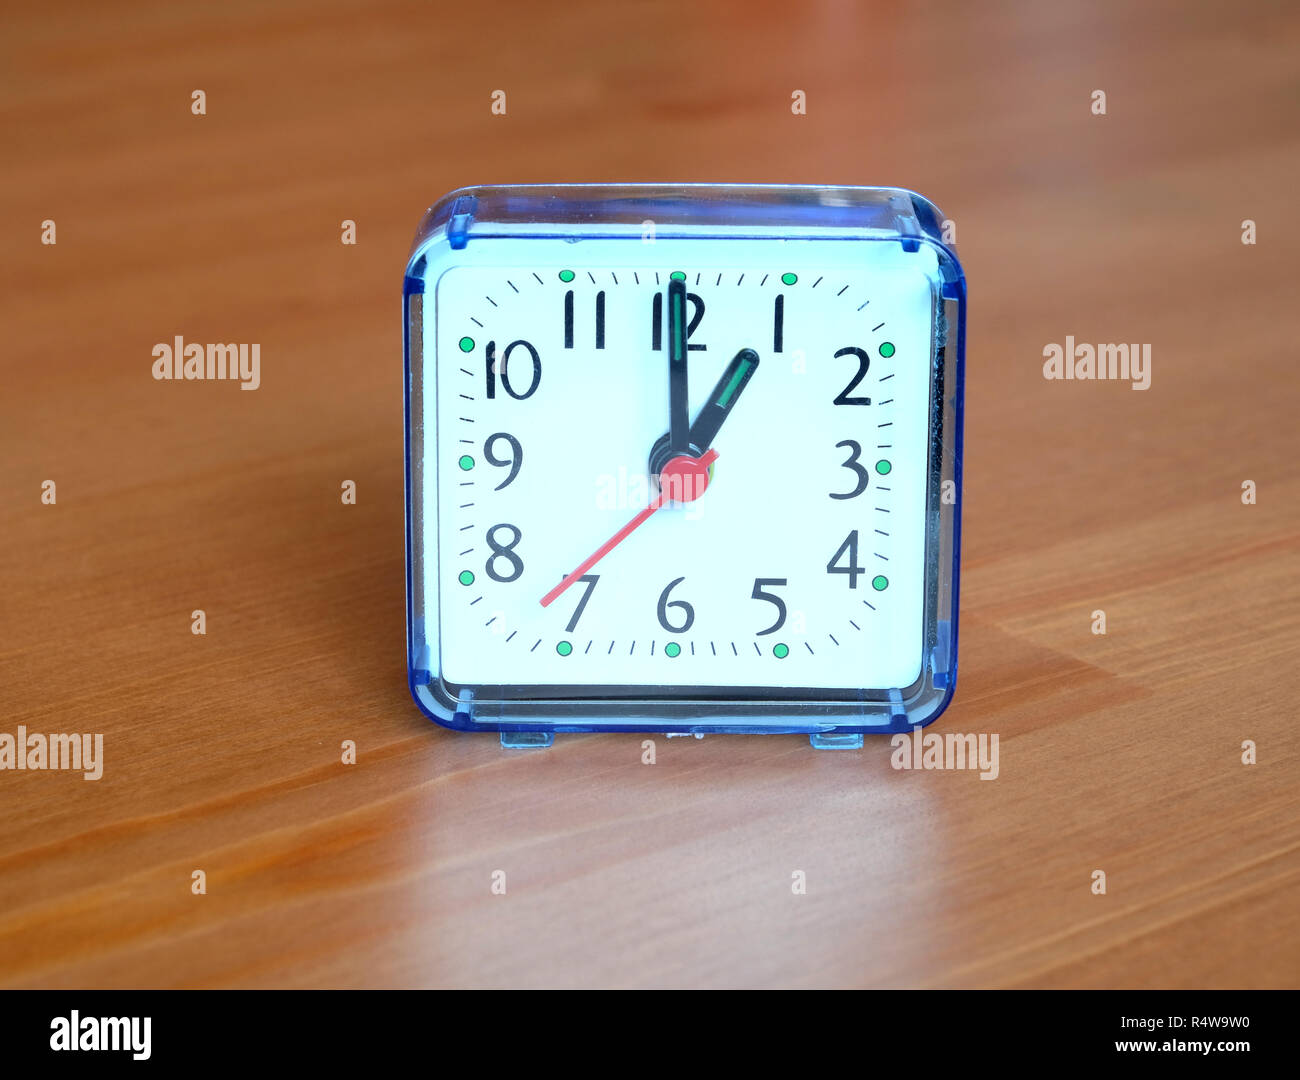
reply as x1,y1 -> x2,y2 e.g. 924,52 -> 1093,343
0,0 -> 1300,988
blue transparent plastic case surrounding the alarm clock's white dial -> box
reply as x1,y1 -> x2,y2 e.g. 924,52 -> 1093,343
403,185 -> 966,749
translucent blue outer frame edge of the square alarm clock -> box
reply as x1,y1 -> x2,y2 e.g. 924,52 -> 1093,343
402,183 -> 967,750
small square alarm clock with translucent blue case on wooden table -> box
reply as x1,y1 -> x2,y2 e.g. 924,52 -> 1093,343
403,185 -> 966,749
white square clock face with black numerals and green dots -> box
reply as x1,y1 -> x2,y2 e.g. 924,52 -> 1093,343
423,240 -> 936,698
